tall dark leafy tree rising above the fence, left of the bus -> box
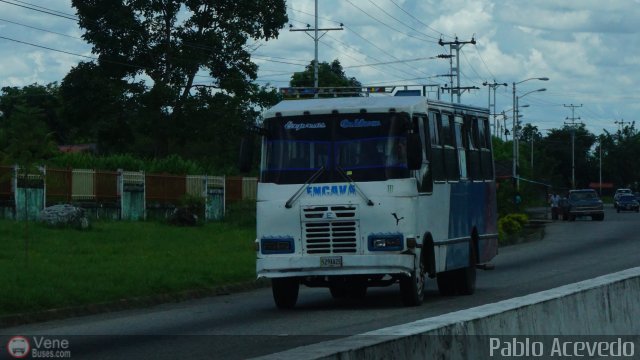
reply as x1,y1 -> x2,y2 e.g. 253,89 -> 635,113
72,0 -> 287,159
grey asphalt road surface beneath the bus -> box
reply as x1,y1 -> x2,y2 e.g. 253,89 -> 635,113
0,208 -> 640,359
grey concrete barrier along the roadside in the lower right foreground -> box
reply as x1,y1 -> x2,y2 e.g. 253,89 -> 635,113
259,267 -> 640,360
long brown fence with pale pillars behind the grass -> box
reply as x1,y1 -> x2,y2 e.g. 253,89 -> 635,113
0,166 -> 257,220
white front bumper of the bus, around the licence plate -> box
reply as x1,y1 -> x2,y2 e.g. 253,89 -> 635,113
256,254 -> 415,278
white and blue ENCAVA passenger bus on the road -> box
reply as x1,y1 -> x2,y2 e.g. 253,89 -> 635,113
256,92 -> 498,308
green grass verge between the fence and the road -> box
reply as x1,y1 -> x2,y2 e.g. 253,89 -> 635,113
0,219 -> 255,316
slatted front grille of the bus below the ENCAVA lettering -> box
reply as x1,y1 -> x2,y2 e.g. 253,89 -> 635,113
302,206 -> 358,254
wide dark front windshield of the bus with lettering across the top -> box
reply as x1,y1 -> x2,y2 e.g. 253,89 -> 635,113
261,113 -> 409,184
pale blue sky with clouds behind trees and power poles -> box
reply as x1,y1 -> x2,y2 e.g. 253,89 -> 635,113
0,0 -> 640,134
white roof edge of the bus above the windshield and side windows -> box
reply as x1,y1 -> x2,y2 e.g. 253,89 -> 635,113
264,96 -> 488,119
